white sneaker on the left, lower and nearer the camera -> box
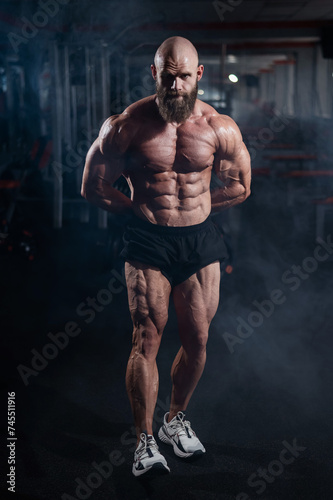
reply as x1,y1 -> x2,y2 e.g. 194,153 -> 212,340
132,432 -> 170,476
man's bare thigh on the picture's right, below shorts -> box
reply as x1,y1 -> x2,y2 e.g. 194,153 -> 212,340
172,262 -> 220,334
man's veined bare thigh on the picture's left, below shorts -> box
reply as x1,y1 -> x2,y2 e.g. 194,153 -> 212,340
125,261 -> 171,332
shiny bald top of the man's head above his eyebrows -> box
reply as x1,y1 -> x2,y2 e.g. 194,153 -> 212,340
154,36 -> 199,69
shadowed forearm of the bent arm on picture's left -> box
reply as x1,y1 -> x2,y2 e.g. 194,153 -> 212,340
82,183 -> 133,215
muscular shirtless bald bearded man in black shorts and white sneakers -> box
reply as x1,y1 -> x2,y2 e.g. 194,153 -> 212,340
82,37 -> 251,476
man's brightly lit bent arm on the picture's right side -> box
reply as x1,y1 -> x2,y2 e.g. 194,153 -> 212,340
211,117 -> 251,212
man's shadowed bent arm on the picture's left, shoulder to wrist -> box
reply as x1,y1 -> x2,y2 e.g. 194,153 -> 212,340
81,117 -> 132,215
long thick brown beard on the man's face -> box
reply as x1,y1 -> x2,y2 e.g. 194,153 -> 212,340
156,82 -> 198,123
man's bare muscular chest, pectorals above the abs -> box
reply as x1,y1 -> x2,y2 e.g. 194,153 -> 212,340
126,122 -> 216,173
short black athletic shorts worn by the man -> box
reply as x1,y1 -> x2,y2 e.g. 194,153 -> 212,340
120,216 -> 228,286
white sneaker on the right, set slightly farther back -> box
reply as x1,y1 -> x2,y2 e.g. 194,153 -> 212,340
158,411 -> 206,458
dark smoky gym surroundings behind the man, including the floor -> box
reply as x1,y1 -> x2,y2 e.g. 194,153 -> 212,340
0,0 -> 333,500
